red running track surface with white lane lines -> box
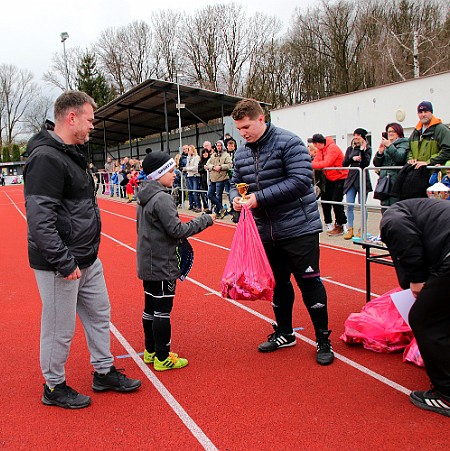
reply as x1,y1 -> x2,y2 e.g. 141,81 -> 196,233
0,186 -> 449,451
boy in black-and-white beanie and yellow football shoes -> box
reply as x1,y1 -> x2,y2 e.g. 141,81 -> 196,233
137,151 -> 216,371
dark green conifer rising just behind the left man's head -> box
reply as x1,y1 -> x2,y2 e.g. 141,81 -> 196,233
76,50 -> 115,107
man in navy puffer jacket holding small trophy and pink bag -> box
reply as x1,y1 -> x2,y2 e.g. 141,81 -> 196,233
230,100 -> 334,365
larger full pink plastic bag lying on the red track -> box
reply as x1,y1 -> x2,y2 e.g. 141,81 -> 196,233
340,288 -> 414,352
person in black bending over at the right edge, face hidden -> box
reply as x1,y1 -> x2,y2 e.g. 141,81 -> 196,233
381,199 -> 450,416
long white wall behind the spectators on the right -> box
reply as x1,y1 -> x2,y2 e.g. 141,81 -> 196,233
271,72 -> 450,151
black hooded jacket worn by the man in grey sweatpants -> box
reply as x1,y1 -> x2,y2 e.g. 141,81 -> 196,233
24,129 -> 101,277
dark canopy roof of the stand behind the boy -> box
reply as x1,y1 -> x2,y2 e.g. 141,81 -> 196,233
90,79 -> 266,146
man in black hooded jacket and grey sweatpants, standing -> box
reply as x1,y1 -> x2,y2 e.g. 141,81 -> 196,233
24,91 -> 141,409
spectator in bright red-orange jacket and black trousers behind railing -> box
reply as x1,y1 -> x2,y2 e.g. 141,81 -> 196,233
312,133 -> 348,236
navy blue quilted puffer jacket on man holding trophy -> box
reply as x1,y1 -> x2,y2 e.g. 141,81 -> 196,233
231,124 -> 322,243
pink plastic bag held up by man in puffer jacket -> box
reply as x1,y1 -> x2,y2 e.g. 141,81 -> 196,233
222,205 -> 275,302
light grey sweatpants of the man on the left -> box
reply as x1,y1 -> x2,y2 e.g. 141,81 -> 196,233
34,259 -> 113,388
